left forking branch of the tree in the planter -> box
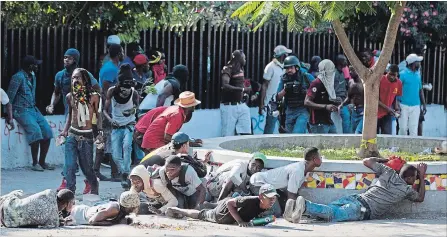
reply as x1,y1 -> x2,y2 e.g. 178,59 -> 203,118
332,20 -> 369,80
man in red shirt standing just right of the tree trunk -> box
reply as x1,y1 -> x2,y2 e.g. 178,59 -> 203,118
377,64 -> 402,134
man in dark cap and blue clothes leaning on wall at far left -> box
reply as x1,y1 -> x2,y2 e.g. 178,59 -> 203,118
8,55 -> 54,171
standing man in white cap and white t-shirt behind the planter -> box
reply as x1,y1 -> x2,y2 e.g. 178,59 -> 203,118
259,45 -> 292,134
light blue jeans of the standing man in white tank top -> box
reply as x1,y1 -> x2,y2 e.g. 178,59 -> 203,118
112,126 -> 135,174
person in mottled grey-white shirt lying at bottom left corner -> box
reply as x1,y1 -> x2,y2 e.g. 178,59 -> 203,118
0,189 -> 75,228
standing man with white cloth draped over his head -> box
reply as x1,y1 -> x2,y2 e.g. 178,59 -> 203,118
304,59 -> 340,133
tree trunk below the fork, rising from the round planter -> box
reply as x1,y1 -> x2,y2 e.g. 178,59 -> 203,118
358,74 -> 381,158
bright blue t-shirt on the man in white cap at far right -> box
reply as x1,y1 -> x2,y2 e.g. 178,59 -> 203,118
399,68 -> 422,106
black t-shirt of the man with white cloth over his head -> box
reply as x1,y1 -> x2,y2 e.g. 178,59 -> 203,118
307,78 -> 333,125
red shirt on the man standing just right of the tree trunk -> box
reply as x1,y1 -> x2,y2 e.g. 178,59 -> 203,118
377,75 -> 402,118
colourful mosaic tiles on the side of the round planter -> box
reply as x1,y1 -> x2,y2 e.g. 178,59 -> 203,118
303,172 -> 447,191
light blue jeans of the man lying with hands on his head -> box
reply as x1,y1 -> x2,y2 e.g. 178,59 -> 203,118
304,195 -> 363,222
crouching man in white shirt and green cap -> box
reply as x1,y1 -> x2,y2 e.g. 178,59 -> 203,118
206,152 -> 267,201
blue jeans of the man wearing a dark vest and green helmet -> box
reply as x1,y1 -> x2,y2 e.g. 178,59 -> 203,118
286,107 -> 309,133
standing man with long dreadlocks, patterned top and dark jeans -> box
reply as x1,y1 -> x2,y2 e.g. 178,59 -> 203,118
60,68 -> 103,195
